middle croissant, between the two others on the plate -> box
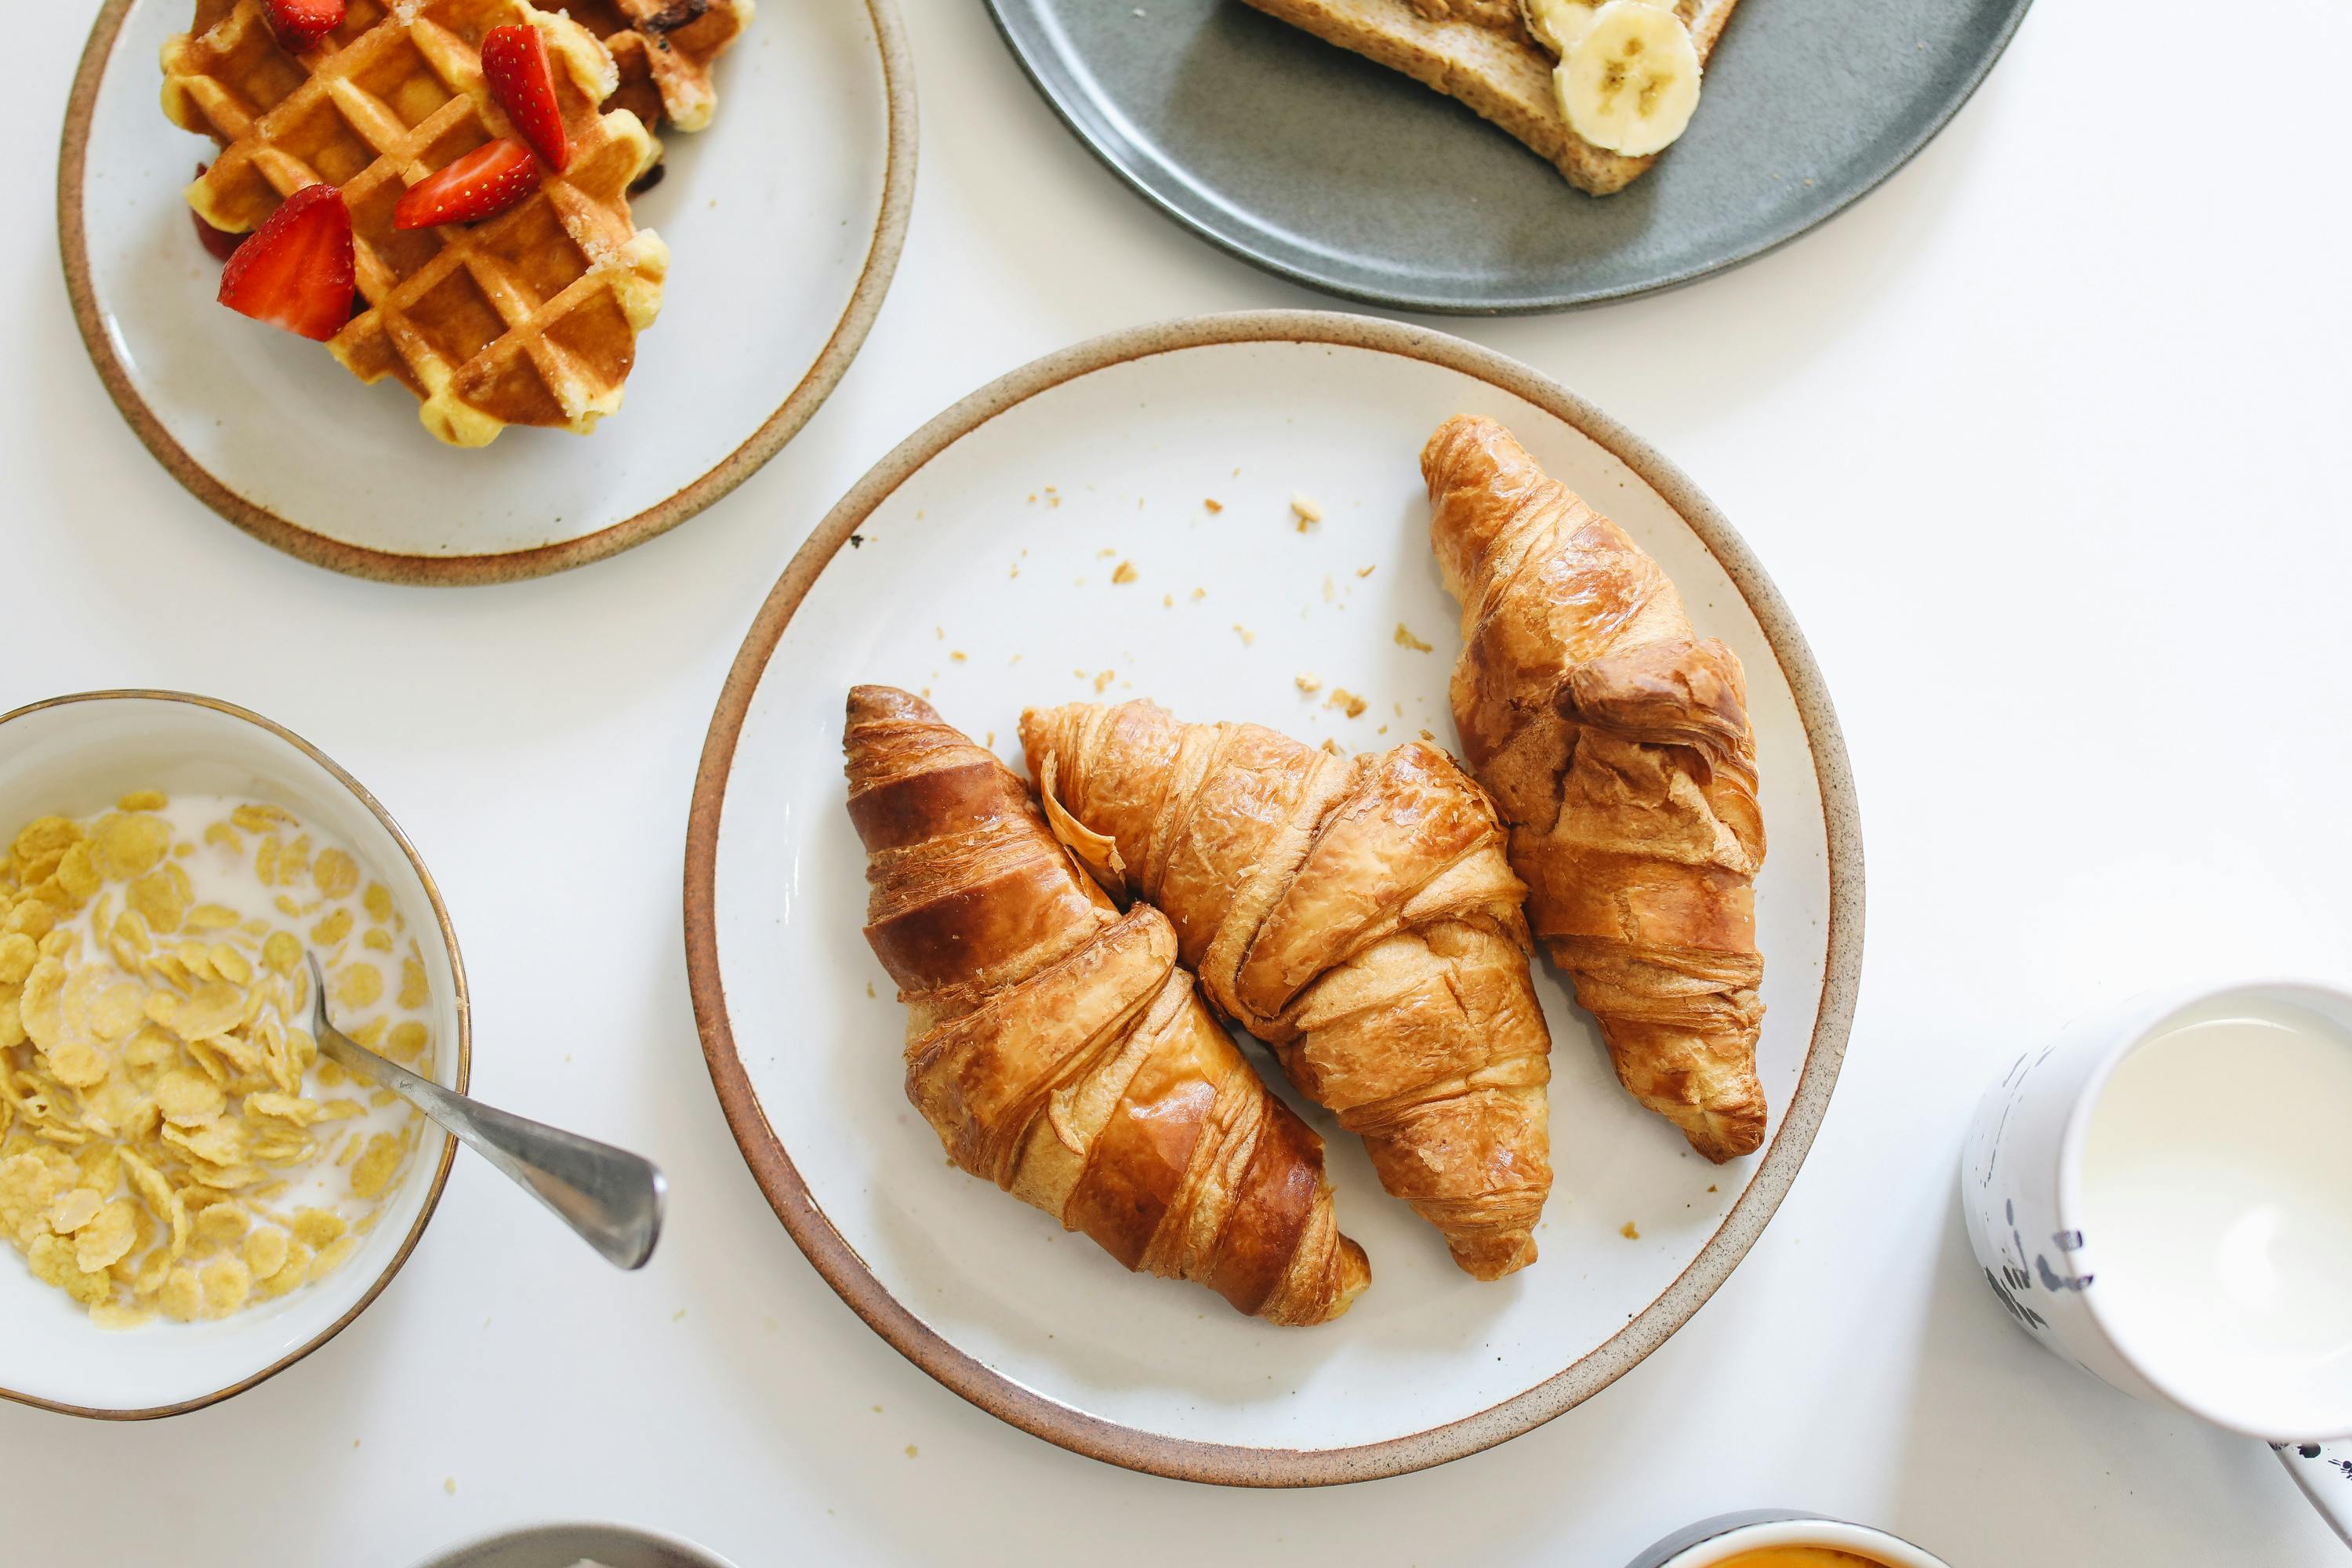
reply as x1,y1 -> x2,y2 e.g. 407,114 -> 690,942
1021,703 -> 1552,1279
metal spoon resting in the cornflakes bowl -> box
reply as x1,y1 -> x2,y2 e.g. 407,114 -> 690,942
303,952 -> 668,1269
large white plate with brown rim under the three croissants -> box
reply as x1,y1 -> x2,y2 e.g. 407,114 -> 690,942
687,313 -> 1860,1483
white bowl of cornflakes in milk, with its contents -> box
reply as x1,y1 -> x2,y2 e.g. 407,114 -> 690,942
0,691 -> 470,1420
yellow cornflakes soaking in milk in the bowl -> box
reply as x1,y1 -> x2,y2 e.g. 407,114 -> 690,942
0,789 -> 433,1328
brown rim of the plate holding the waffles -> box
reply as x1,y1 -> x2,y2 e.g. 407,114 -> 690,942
56,0 -> 915,588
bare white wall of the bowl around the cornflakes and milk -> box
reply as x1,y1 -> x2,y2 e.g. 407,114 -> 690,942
0,691 -> 473,1420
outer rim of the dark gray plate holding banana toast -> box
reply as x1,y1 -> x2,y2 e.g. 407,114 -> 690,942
988,0 -> 2032,315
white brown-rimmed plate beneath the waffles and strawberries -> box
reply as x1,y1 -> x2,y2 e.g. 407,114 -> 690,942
59,0 -> 915,583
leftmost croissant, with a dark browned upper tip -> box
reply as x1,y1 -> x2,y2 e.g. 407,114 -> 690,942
842,687 -> 1371,1323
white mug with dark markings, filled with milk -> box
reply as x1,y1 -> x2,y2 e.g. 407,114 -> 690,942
1959,980 -> 2352,1544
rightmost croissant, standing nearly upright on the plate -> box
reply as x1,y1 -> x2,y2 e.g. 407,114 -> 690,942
1421,416 -> 1764,1161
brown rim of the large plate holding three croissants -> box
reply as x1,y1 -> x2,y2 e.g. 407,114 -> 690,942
684,310 -> 1863,1486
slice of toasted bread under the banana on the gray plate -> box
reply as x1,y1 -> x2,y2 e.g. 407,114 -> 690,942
1249,0 -> 1738,195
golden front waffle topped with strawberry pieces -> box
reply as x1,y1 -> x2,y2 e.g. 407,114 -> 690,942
162,0 -> 670,447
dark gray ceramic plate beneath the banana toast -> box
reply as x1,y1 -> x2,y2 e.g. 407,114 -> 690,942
990,0 -> 2030,313
